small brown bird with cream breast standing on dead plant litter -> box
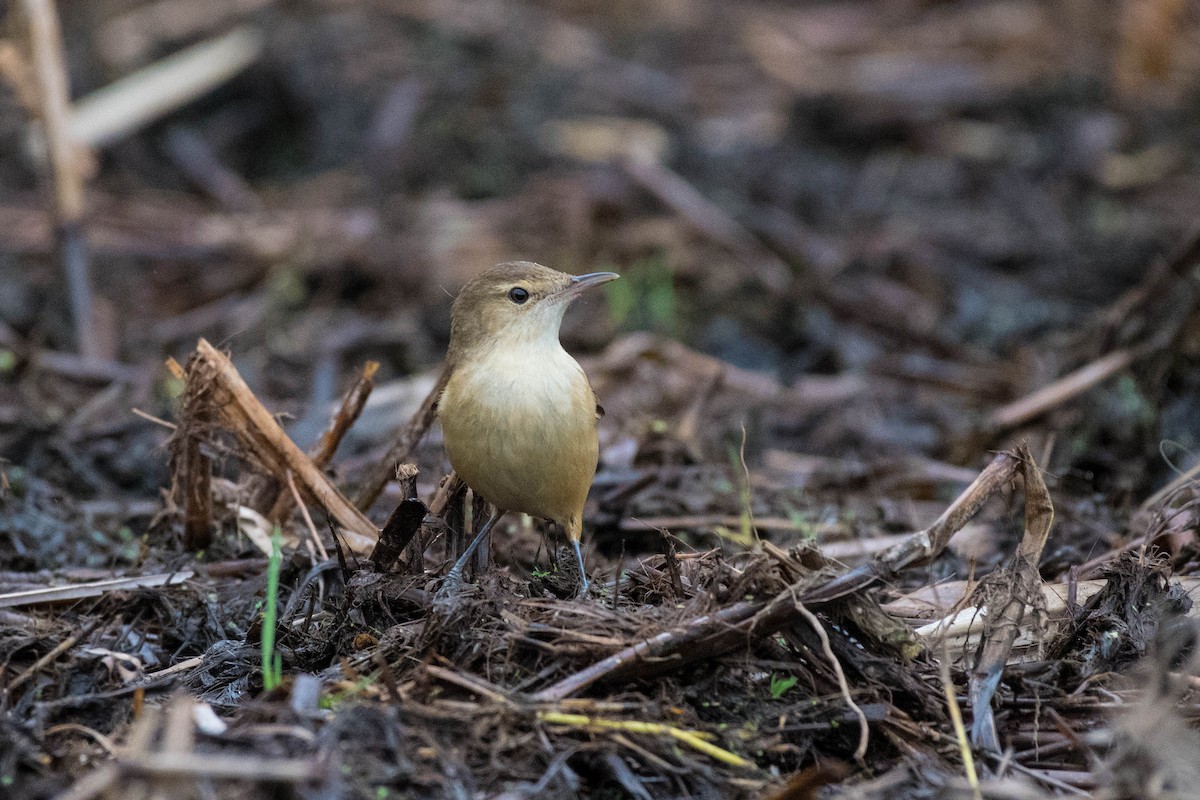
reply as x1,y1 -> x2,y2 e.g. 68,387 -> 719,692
437,261 -> 619,594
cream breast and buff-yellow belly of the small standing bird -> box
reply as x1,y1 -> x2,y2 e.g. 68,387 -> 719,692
438,350 -> 599,527
